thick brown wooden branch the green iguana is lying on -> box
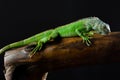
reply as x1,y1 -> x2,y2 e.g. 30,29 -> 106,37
4,32 -> 120,80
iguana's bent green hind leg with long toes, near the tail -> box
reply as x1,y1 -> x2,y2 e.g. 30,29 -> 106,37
30,30 -> 58,57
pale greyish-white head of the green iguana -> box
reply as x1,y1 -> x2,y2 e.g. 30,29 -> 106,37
92,17 -> 111,35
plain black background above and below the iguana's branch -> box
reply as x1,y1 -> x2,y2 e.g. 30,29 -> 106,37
0,0 -> 120,80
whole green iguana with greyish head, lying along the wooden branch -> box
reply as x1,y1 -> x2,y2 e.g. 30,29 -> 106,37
0,17 -> 110,56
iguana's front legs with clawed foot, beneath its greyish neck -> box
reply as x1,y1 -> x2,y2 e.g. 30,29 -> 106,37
75,29 -> 93,46
